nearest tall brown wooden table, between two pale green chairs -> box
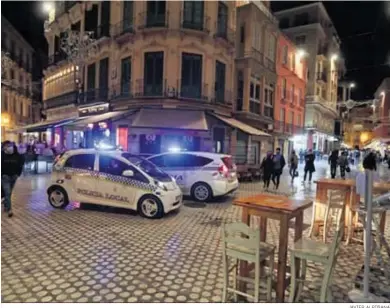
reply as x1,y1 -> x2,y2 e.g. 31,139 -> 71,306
233,194 -> 313,302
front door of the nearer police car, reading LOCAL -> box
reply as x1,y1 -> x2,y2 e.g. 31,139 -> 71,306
99,154 -> 149,210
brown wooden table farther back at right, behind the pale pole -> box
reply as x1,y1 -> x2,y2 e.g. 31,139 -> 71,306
313,178 -> 390,235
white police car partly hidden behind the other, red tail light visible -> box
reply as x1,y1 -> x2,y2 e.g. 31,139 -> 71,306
147,152 -> 238,202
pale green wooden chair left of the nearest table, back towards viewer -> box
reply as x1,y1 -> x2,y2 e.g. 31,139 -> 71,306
222,222 -> 275,303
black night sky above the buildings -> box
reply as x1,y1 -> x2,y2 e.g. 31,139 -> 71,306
1,1 -> 390,100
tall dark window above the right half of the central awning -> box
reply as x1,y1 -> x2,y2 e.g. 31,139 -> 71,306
180,53 -> 203,99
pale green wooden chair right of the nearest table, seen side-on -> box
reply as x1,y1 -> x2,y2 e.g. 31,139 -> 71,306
289,206 -> 345,303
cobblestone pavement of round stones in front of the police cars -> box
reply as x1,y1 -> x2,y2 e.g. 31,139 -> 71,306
1,162 -> 390,302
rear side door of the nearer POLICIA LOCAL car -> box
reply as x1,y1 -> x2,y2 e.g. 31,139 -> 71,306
63,153 -> 100,203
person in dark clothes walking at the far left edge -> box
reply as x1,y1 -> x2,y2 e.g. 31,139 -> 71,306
1,141 -> 24,217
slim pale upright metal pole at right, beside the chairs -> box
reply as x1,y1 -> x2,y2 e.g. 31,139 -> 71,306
363,169 -> 374,298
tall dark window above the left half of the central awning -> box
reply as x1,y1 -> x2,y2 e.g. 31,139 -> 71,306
144,51 -> 164,96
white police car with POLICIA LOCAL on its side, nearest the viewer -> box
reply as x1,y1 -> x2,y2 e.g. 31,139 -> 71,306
47,149 -> 183,218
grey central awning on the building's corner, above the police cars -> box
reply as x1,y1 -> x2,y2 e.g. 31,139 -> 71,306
131,109 -> 208,131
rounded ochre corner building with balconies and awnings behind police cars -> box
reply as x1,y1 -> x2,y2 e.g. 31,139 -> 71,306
41,1 -> 268,161
